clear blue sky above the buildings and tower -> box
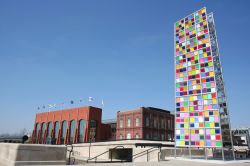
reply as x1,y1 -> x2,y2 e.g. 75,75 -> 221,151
0,0 -> 250,133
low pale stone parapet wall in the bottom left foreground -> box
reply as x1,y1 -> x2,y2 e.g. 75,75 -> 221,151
0,143 -> 67,166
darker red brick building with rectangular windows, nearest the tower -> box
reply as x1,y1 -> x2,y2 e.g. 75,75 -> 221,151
116,107 -> 174,141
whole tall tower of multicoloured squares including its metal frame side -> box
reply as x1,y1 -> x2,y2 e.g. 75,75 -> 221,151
174,8 -> 234,159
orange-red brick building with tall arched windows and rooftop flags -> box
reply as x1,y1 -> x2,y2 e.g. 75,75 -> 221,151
32,106 -> 111,144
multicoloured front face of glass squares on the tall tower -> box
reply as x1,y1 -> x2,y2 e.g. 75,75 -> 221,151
175,8 -> 224,147
